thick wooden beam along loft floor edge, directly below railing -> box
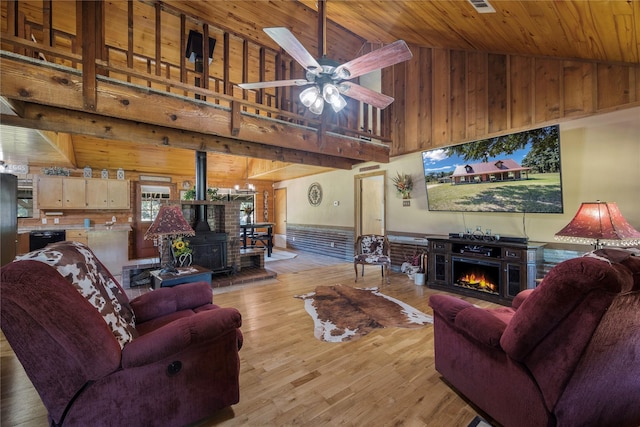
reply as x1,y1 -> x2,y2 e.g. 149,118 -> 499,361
0,55 -> 389,168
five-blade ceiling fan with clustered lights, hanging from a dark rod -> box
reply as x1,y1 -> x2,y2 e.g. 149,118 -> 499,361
238,0 -> 413,115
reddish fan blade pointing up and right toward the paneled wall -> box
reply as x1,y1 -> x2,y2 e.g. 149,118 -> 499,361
333,40 -> 413,80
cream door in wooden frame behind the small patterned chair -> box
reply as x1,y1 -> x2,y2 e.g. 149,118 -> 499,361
355,171 -> 386,236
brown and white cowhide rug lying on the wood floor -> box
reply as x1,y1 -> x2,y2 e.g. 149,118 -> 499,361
296,285 -> 433,342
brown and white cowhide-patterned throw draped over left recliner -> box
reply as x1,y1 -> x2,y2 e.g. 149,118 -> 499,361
16,242 -> 138,348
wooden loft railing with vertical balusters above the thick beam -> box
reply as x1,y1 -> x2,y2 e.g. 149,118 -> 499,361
1,1 -> 389,142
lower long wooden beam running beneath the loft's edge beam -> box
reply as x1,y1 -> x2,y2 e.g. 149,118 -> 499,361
0,103 -> 357,169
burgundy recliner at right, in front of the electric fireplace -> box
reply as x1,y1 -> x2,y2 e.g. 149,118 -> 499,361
429,249 -> 640,427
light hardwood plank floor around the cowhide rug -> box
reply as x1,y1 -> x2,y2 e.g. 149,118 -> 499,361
0,253 -> 500,427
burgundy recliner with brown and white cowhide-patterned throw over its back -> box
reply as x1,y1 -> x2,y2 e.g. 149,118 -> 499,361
0,242 -> 242,426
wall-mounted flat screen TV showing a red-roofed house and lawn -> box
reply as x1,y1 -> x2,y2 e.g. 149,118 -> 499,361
422,125 -> 563,213
